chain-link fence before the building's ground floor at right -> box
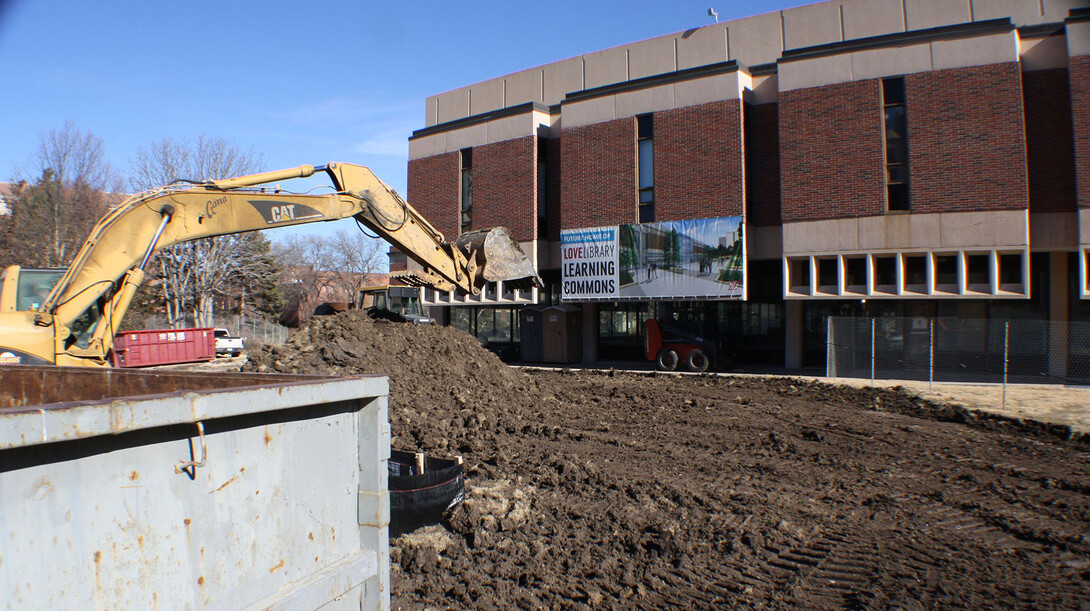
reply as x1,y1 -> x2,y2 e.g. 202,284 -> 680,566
826,316 -> 1090,386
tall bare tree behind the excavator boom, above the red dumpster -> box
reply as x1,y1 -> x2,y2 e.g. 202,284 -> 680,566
131,135 -> 270,327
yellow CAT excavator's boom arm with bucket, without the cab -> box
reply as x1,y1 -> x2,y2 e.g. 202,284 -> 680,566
39,163 -> 542,358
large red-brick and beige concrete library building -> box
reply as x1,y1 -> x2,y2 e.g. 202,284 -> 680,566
401,0 -> 1090,367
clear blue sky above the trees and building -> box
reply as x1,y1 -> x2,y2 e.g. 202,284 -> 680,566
0,0 -> 804,238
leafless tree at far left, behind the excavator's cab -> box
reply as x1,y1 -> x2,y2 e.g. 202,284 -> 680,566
0,121 -> 119,267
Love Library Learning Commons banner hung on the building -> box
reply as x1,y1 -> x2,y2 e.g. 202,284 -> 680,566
560,217 -> 746,302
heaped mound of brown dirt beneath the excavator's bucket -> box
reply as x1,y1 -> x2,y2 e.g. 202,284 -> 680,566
246,310 -> 535,460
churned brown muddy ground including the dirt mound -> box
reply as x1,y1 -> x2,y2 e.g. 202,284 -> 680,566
250,313 -> 1090,609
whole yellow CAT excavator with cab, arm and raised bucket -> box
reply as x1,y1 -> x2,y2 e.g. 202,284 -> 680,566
0,163 -> 542,367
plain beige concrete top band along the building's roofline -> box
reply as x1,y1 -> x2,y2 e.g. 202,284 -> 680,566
425,0 -> 1076,126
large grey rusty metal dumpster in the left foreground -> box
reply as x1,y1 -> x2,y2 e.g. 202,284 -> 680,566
0,366 -> 390,609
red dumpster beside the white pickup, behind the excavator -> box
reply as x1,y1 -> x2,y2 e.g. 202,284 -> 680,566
113,328 -> 216,367
